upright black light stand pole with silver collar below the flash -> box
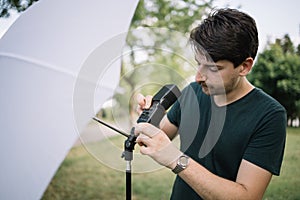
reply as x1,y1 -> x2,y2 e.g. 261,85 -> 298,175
122,128 -> 136,200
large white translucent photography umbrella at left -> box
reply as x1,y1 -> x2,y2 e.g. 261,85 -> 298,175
0,0 -> 137,199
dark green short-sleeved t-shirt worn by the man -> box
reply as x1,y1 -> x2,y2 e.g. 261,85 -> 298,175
167,83 -> 286,200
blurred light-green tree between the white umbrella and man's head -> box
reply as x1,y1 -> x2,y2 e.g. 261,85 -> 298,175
113,0 -> 213,120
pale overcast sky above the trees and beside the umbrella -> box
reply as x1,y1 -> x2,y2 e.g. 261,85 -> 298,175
0,0 -> 300,51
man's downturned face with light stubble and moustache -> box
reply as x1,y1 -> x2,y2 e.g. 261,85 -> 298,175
196,58 -> 240,95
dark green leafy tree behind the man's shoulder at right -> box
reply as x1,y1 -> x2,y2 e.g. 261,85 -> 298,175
250,35 -> 300,125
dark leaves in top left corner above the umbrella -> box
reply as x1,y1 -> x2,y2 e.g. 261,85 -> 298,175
0,0 -> 38,17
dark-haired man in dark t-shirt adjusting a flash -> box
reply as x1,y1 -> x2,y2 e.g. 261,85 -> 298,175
135,9 -> 286,200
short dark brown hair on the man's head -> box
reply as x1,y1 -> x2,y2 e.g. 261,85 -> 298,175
190,8 -> 258,67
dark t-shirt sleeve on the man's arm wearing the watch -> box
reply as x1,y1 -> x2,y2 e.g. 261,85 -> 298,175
243,110 -> 286,175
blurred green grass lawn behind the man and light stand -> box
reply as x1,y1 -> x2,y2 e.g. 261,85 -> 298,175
42,128 -> 300,200
